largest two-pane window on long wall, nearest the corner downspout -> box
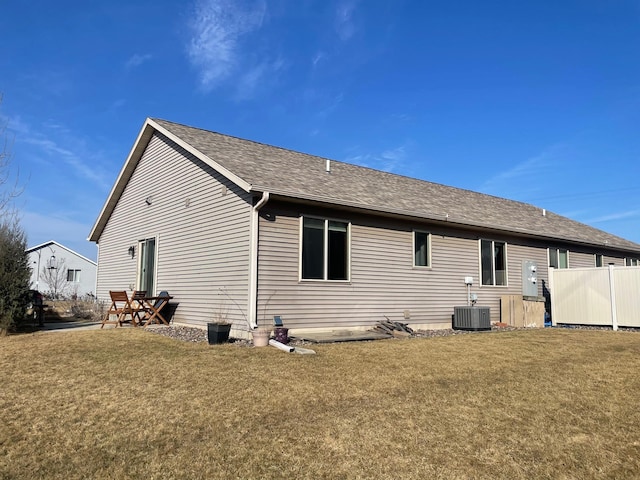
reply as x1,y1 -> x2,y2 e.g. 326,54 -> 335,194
300,217 -> 350,281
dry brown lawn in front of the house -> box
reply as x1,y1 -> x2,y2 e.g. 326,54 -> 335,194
0,329 -> 640,479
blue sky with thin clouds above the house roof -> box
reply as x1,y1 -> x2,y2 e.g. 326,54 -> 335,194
0,0 -> 640,259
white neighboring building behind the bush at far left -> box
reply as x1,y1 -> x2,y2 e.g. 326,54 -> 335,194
27,240 -> 97,298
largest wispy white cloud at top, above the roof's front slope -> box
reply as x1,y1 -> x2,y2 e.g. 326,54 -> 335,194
187,0 -> 266,90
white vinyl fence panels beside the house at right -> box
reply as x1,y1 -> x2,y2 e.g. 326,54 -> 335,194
549,265 -> 640,330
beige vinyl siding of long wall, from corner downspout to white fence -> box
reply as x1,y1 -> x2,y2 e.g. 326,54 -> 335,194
258,204 -> 547,329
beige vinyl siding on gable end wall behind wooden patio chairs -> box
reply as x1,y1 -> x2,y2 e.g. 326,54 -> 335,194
98,134 -> 251,328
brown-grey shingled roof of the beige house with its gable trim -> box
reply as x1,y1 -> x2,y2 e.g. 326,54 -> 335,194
90,119 -> 640,252
